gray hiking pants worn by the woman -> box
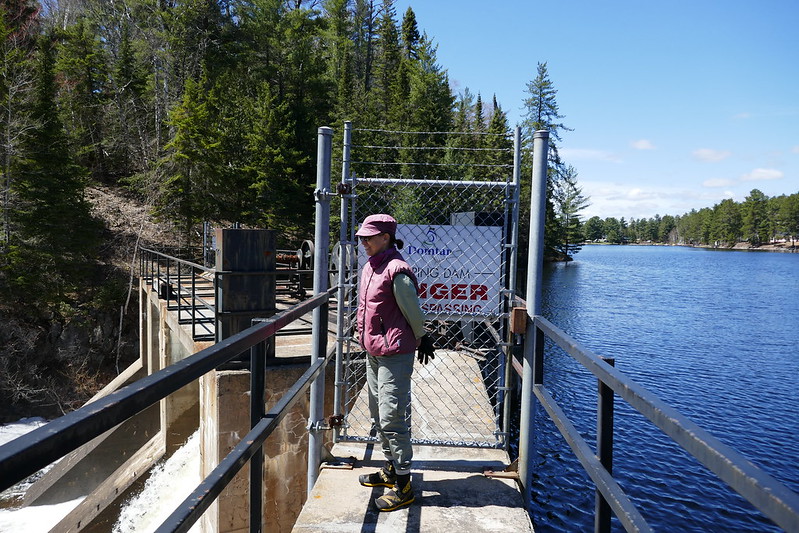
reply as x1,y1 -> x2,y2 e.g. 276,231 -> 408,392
366,352 -> 414,474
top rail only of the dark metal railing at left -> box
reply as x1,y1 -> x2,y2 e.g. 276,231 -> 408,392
0,292 -> 330,491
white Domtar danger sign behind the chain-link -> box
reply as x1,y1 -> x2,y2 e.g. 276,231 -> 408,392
397,224 -> 502,318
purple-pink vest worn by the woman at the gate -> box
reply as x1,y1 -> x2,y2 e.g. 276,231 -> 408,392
358,247 -> 419,355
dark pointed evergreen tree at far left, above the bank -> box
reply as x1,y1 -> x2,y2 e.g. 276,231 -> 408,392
6,36 -> 99,305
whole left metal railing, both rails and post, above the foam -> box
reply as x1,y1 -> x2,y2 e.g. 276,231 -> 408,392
0,291 -> 333,532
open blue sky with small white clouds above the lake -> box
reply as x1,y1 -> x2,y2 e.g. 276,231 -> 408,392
395,0 -> 799,220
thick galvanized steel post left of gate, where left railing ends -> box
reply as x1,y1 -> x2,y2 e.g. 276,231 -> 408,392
308,126 -> 333,494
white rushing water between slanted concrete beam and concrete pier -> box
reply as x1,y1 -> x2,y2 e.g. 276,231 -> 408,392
113,432 -> 201,533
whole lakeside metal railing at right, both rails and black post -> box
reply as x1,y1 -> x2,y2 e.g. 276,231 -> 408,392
513,308 -> 799,532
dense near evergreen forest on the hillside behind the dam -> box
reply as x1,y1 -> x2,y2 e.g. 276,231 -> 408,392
0,0 -> 585,316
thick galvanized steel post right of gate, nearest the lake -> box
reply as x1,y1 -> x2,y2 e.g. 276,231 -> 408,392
519,130 -> 549,508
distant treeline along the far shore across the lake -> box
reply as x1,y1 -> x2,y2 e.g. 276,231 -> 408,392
582,189 -> 799,247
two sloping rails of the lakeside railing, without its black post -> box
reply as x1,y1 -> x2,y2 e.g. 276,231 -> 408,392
512,310 -> 799,531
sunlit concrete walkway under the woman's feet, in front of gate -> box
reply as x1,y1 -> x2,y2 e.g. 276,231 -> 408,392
293,442 -> 533,533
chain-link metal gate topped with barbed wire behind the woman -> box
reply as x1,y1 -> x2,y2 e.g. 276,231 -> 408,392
331,122 -> 521,448
